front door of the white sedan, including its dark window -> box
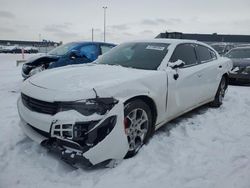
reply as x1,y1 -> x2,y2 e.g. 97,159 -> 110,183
167,43 -> 206,119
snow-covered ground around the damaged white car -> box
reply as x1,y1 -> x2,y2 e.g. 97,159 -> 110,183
0,54 -> 250,188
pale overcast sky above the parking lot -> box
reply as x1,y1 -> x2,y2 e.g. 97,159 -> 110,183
0,0 -> 250,43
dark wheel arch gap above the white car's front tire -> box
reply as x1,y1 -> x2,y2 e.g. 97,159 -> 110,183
124,95 -> 157,126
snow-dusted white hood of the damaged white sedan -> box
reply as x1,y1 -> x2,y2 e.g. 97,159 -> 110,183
27,64 -> 156,97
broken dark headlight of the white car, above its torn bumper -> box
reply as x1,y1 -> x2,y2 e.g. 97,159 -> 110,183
58,97 -> 118,116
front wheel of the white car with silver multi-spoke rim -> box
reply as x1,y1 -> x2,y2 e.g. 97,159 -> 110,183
124,100 -> 153,158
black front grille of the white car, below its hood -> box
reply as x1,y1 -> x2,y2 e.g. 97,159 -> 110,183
21,93 -> 58,115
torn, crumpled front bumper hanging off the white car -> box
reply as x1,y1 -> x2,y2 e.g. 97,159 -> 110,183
18,99 -> 129,166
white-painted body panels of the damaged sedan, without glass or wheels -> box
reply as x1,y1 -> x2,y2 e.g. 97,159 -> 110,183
18,39 -> 231,164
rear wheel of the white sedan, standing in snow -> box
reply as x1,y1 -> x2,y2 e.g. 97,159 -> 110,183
210,76 -> 227,108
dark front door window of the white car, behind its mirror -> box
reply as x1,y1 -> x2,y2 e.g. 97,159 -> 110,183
170,44 -> 198,66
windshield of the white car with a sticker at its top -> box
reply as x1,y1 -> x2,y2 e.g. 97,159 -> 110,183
97,42 -> 169,70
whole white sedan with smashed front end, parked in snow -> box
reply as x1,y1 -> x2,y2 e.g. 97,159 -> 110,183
18,39 -> 232,166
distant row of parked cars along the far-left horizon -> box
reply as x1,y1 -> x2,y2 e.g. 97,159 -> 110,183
0,46 -> 38,54
